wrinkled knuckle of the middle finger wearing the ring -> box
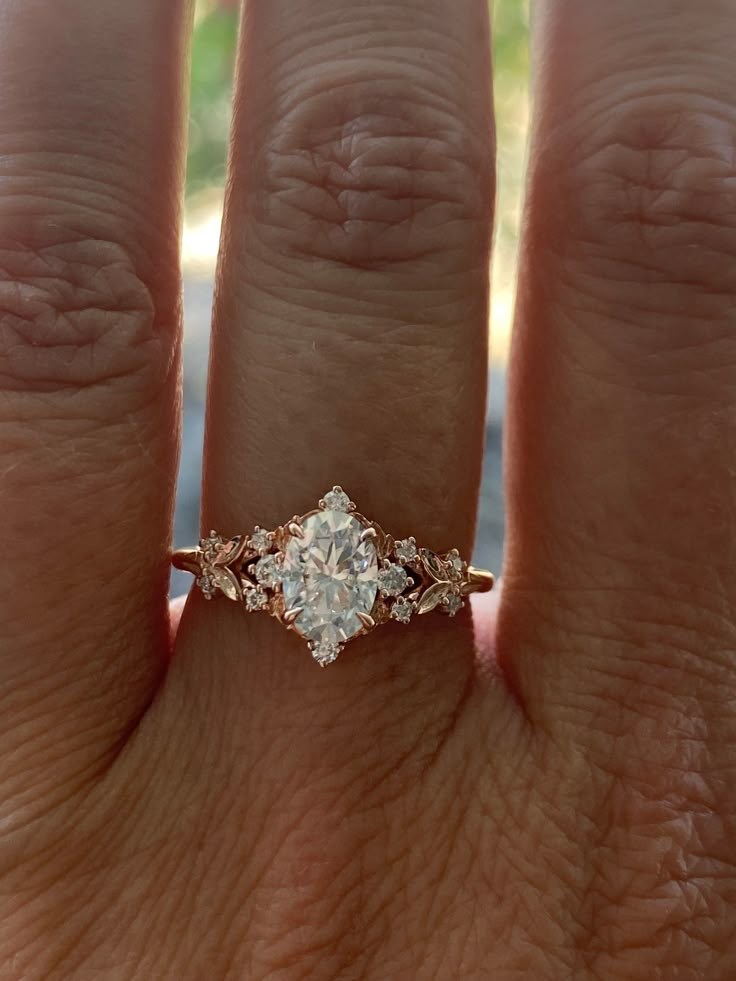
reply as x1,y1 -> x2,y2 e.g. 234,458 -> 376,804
251,71 -> 492,272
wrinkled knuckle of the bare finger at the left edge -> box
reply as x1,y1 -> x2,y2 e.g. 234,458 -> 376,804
0,221 -> 172,407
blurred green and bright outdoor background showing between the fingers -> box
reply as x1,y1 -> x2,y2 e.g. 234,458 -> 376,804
172,0 -> 528,593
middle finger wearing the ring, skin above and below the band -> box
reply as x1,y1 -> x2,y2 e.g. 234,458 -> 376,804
173,0 -> 492,738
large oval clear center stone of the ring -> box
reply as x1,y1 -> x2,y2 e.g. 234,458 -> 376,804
282,511 -> 378,644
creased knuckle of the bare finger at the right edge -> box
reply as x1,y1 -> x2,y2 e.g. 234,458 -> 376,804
539,95 -> 736,302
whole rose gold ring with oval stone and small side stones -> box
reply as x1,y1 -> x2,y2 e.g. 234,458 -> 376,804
172,486 -> 494,667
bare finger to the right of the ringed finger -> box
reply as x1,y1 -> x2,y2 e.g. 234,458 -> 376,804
500,0 -> 736,719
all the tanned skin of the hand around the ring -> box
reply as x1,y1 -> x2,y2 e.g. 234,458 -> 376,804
0,0 -> 736,981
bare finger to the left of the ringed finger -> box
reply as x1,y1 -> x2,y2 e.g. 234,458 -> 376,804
0,0 -> 193,804
